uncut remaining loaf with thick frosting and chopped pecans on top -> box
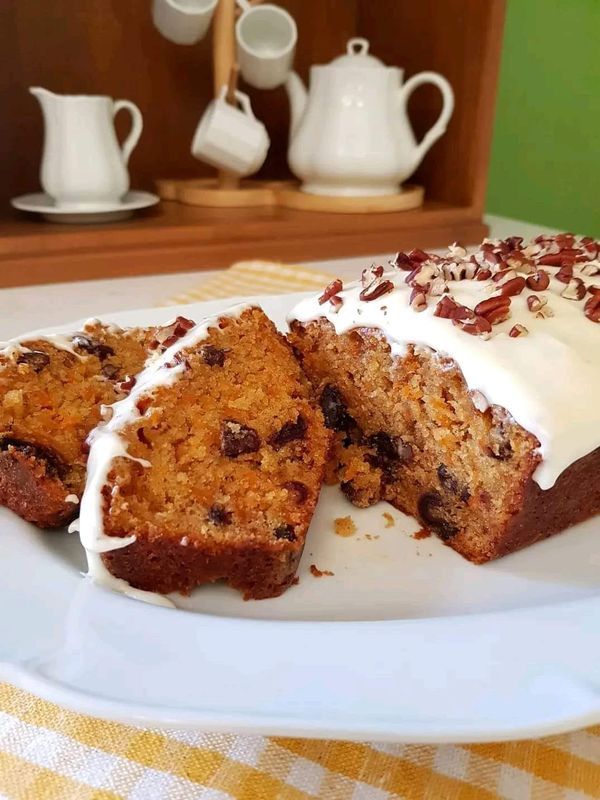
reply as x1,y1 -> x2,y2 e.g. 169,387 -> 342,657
289,234 -> 600,563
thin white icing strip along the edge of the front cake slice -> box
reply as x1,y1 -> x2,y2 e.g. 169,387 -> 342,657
77,303 -> 251,606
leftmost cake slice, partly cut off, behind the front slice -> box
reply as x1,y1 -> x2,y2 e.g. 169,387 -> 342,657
0,320 -> 147,528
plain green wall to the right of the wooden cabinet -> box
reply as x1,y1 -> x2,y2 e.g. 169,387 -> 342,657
488,0 -> 600,237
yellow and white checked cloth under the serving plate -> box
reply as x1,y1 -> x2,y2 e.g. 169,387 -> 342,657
0,262 -> 600,800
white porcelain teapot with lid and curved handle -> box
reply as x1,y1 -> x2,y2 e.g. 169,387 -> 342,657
286,39 -> 454,197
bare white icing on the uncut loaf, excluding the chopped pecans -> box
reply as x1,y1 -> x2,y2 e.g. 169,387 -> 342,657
288,264 -> 600,489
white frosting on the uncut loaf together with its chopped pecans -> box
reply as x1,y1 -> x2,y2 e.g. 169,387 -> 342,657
288,237 -> 600,489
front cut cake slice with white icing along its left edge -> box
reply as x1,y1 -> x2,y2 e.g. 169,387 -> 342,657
79,306 -> 331,599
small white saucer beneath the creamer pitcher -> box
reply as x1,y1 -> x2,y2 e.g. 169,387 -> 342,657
10,192 -> 160,225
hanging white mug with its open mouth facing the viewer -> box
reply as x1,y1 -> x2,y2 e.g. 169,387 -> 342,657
235,0 -> 298,89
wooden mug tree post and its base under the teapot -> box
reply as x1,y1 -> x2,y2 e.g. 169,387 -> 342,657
156,0 -> 424,214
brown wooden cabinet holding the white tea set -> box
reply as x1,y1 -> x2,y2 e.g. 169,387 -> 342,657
0,0 -> 504,286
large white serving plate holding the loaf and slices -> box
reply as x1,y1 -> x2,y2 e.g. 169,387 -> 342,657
0,295 -> 600,742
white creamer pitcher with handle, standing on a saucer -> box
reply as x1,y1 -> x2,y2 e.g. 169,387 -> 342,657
29,86 -> 143,210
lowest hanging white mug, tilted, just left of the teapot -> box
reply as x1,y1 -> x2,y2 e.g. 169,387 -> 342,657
192,86 -> 271,177
